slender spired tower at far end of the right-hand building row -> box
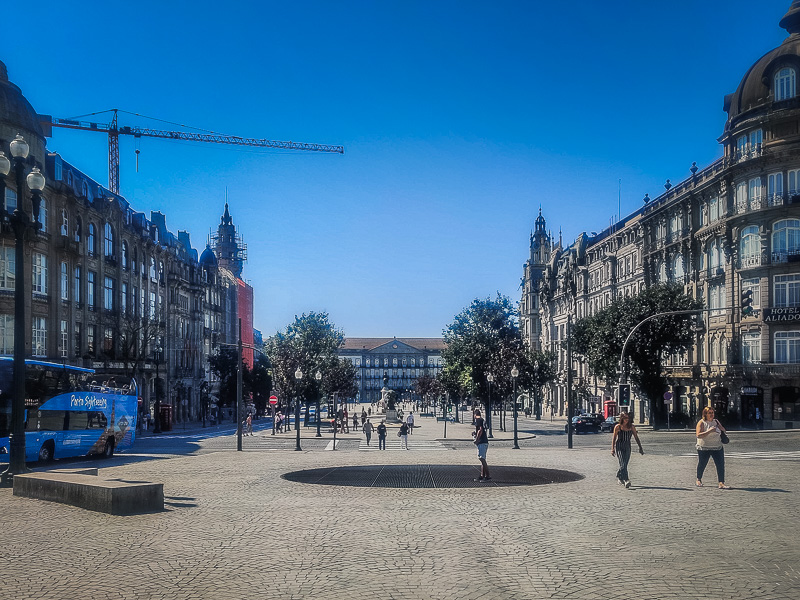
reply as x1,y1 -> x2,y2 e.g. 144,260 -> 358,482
520,208 -> 552,350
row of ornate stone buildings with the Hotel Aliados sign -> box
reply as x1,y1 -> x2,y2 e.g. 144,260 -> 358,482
520,1 -> 800,428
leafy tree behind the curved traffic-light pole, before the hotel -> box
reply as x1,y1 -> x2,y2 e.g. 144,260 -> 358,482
572,284 -> 703,425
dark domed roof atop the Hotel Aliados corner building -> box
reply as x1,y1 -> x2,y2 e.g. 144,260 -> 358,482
725,0 -> 800,129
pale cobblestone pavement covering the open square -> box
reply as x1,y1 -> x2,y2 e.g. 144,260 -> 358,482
0,412 -> 800,600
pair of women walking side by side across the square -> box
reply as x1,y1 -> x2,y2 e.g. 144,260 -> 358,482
611,406 -> 731,490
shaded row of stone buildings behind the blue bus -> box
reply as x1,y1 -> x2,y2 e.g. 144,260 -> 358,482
0,55 -> 252,421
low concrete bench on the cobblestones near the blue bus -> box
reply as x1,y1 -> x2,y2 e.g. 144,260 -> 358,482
14,471 -> 164,515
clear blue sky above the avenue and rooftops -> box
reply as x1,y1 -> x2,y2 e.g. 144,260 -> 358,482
0,0 -> 790,337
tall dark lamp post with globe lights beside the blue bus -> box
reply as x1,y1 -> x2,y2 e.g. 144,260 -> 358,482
0,134 -> 45,486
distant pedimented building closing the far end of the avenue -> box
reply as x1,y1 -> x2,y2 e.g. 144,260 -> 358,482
339,338 -> 445,402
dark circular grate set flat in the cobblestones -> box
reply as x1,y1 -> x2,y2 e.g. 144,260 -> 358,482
282,465 -> 583,488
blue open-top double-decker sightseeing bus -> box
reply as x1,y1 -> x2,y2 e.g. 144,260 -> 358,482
0,357 -> 139,463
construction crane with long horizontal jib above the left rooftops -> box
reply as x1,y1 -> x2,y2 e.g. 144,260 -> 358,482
39,108 -> 344,194
